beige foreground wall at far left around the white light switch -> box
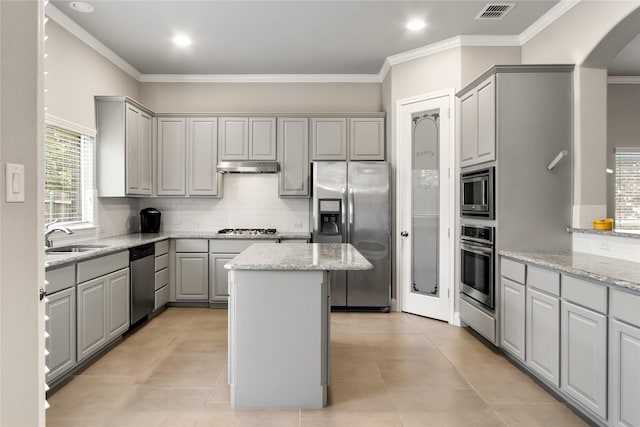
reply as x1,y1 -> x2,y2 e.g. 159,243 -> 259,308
0,1 -> 45,427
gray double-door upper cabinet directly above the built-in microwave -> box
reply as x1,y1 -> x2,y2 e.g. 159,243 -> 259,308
460,75 -> 496,167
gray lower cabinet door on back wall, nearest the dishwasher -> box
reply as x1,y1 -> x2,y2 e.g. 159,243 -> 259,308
176,253 -> 209,301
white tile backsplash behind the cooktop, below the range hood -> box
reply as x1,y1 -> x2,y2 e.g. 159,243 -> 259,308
140,174 -> 309,232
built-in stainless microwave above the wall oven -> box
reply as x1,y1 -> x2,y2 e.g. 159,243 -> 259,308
460,167 -> 495,219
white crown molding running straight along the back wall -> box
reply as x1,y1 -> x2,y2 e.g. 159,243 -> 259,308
138,74 -> 380,83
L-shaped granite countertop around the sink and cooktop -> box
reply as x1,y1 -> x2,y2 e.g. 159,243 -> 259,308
44,231 -> 311,268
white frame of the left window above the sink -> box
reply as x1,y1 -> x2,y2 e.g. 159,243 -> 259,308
45,114 -> 98,237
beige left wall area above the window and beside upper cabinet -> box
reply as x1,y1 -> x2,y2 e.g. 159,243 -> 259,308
45,19 -> 139,129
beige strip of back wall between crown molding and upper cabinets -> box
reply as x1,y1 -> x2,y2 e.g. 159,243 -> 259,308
140,83 -> 382,113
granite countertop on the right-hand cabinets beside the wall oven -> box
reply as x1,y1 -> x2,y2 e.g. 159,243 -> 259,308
500,251 -> 640,292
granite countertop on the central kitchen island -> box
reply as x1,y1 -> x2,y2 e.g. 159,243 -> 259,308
224,243 -> 373,271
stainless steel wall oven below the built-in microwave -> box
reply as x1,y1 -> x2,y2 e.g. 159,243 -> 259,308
460,225 -> 495,311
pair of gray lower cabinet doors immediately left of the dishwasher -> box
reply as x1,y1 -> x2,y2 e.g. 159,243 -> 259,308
77,267 -> 129,362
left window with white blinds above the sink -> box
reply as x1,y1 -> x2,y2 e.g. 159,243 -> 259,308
44,124 -> 94,225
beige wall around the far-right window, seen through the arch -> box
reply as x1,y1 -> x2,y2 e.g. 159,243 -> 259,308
607,84 -> 640,218
